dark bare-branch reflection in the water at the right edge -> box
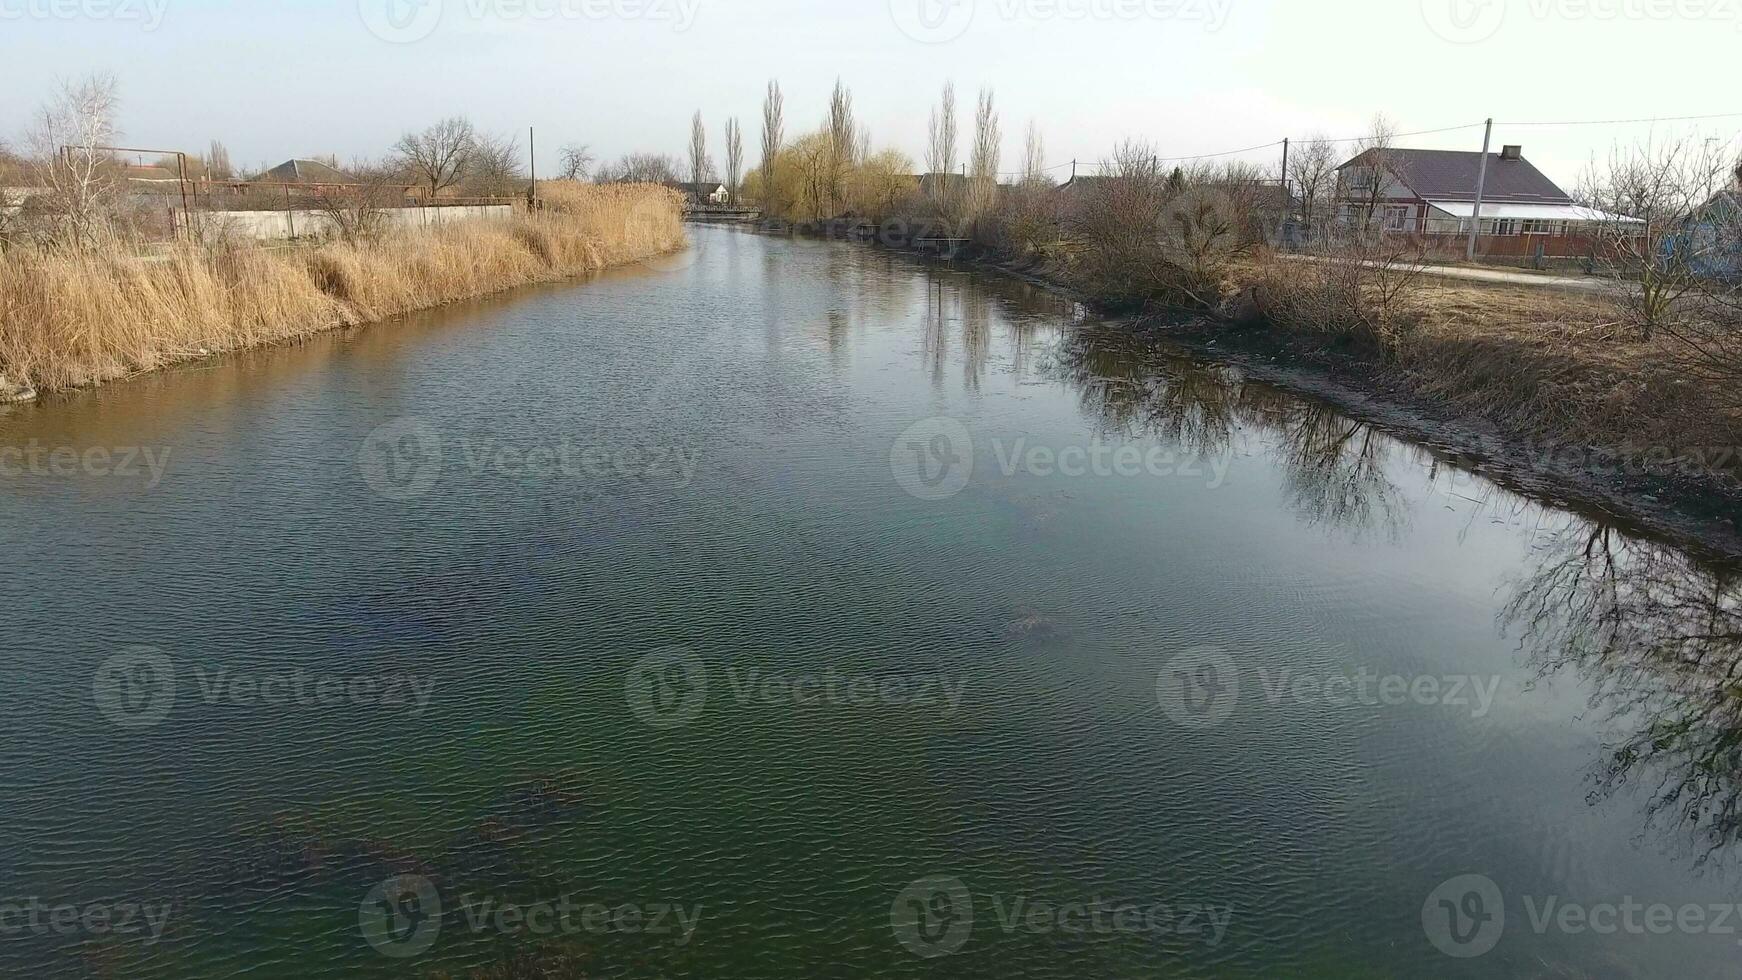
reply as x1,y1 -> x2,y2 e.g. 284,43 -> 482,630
1505,520 -> 1742,865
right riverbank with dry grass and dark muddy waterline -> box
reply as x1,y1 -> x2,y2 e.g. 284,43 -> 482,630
850,229 -> 1742,559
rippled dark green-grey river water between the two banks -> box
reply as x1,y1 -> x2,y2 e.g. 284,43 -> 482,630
0,228 -> 1742,978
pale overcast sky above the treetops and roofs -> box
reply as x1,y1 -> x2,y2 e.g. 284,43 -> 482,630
0,0 -> 1742,186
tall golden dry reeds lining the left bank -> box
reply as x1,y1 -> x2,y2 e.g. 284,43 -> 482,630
0,183 -> 685,390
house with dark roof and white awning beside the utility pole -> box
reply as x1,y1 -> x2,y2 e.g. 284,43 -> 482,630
1336,146 -> 1627,258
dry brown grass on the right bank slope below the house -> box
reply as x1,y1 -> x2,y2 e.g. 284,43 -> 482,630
1242,259 -> 1742,487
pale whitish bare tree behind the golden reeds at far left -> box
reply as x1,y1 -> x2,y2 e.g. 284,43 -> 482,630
30,75 -> 120,247
